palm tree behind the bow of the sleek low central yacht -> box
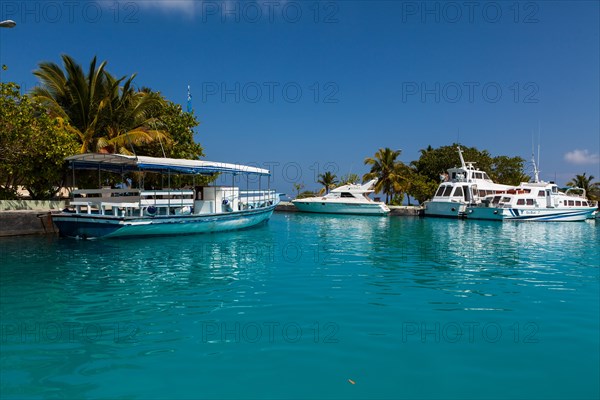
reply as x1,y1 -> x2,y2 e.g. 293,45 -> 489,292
363,147 -> 406,203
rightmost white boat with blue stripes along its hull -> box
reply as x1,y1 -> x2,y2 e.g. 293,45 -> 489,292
466,162 -> 598,221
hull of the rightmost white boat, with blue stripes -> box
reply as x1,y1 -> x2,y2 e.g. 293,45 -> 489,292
466,207 -> 595,222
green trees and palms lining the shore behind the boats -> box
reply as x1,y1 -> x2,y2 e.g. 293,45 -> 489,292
0,55 -> 600,205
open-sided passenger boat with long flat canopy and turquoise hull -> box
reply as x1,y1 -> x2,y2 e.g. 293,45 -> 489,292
53,154 -> 279,239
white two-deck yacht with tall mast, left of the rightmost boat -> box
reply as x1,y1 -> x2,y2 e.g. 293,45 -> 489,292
424,147 -> 512,217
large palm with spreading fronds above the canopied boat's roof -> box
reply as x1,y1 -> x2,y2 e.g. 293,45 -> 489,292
32,55 -> 168,153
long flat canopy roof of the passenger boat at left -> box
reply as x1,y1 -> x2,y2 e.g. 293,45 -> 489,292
66,153 -> 271,176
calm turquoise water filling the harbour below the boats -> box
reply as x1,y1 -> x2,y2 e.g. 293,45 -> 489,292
0,214 -> 600,399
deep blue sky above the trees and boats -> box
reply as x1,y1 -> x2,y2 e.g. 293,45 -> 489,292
0,0 -> 600,193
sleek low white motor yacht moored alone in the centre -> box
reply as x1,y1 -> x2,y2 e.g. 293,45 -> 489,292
292,179 -> 390,215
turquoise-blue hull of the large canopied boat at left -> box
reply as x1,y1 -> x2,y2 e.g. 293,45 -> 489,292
53,205 -> 275,239
